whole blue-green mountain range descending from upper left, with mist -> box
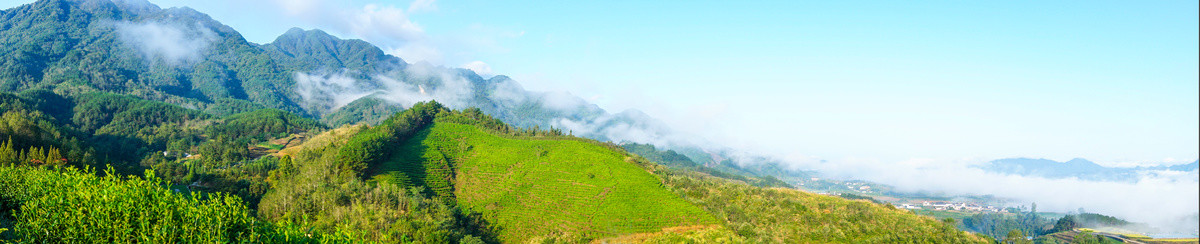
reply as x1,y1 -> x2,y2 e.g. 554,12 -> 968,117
0,0 -> 666,144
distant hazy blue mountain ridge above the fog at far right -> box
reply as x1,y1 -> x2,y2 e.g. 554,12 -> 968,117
979,157 -> 1200,181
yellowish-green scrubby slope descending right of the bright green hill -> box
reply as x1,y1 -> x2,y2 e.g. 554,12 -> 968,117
659,171 -> 988,243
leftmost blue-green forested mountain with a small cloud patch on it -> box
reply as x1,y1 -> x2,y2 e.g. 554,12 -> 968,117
0,0 -> 304,113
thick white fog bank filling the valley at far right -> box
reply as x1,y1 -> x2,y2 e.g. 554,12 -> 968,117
793,159 -> 1200,233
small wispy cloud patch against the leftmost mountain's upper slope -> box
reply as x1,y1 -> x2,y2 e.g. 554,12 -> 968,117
116,22 -> 216,65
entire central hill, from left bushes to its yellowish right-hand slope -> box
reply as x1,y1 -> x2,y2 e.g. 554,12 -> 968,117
262,102 -> 986,243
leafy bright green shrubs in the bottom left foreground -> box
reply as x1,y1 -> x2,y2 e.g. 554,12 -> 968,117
0,167 -> 355,243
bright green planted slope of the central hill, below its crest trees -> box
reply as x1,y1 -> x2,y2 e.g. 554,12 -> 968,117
372,123 -> 716,242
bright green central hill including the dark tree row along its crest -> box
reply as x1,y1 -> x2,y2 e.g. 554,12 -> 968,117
288,102 -> 716,242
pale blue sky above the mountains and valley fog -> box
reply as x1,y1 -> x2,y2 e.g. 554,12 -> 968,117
0,0 -> 1200,165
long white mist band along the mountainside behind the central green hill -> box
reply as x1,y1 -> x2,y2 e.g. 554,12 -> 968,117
294,64 -> 691,148
